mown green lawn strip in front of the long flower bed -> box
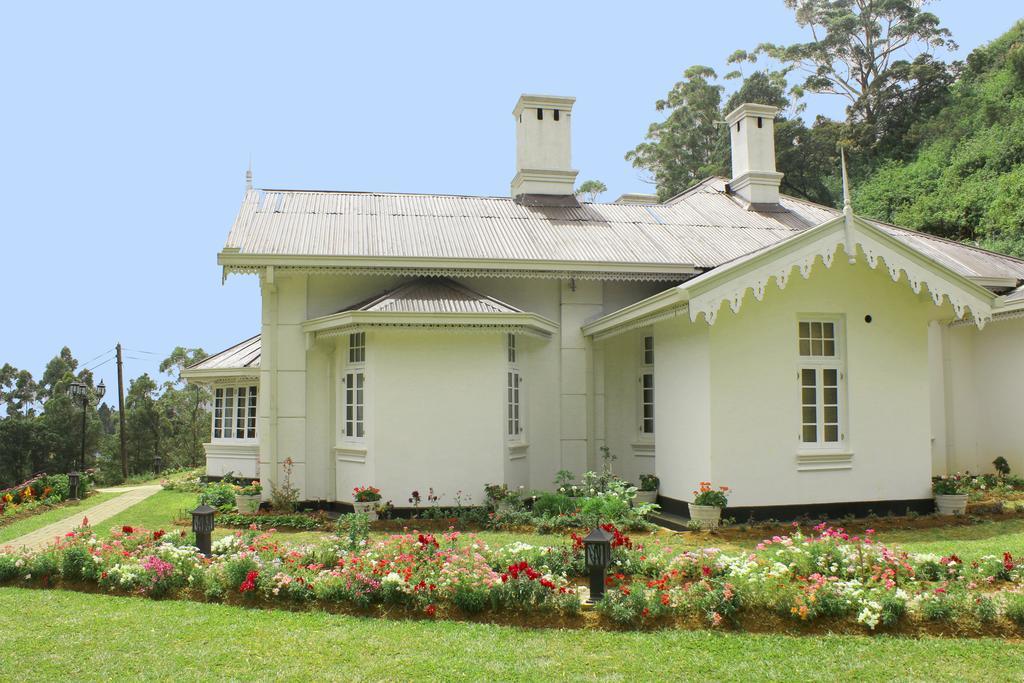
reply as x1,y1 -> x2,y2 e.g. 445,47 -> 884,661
0,588 -> 1024,682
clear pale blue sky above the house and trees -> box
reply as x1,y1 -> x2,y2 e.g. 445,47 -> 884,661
0,0 -> 1020,397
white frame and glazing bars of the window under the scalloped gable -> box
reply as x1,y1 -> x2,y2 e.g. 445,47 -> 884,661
796,314 -> 849,451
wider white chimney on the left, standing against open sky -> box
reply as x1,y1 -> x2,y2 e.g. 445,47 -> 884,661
512,95 -> 579,197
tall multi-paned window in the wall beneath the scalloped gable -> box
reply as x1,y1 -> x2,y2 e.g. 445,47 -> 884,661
797,319 -> 846,447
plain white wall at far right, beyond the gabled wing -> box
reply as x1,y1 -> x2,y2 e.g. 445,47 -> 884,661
938,318 -> 1024,473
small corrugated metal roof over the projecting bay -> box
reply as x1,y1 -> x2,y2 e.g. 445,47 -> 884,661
339,278 -> 522,313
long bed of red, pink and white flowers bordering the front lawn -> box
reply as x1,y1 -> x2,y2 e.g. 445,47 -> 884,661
6,515 -> 1024,637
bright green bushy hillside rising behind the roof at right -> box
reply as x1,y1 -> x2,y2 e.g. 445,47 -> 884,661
853,20 -> 1024,257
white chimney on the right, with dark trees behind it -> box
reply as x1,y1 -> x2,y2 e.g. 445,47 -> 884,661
725,102 -> 782,207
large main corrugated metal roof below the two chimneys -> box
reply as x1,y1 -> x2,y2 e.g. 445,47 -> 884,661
225,178 -> 1024,280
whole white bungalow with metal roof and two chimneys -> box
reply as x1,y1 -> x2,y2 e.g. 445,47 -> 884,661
186,95 -> 1024,516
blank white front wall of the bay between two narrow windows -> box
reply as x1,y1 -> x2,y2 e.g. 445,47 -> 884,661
364,330 -> 507,506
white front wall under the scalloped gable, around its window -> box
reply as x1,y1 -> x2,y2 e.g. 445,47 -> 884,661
708,259 -> 949,507
